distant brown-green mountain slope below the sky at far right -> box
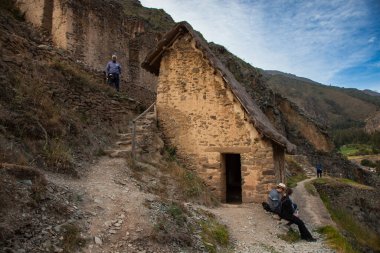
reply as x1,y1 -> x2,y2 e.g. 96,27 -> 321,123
263,71 -> 380,129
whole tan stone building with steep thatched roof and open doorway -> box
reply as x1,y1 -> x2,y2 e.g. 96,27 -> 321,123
142,22 -> 295,203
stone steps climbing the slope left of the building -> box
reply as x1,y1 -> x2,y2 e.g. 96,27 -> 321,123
105,112 -> 163,158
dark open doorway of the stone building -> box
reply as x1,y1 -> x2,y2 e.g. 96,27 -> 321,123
224,154 -> 241,203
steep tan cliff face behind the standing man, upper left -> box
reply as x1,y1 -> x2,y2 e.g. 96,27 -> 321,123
17,0 -> 174,102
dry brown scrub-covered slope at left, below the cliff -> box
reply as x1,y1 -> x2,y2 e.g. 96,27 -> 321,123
0,1 -> 137,174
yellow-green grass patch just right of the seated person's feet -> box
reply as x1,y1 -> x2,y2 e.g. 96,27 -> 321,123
317,226 -> 357,253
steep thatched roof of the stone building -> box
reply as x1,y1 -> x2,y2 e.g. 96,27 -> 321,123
142,22 -> 296,153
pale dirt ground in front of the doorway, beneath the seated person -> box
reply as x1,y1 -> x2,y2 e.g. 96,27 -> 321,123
209,204 -> 333,253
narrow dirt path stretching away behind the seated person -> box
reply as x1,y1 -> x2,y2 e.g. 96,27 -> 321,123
293,177 -> 335,227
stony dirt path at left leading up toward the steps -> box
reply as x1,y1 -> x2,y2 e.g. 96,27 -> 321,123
48,157 -> 159,253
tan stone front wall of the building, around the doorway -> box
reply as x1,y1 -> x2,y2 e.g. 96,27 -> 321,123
157,34 -> 282,202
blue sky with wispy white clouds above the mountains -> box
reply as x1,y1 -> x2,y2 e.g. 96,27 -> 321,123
140,0 -> 380,91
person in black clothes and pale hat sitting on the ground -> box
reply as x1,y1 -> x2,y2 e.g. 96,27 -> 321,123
280,189 -> 316,242
